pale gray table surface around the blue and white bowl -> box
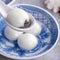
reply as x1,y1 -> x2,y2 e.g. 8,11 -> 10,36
0,0 -> 60,60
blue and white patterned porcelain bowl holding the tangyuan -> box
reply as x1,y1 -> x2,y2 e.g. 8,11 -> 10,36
0,4 -> 59,59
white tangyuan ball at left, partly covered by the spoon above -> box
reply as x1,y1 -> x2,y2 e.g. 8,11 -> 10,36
4,26 -> 22,41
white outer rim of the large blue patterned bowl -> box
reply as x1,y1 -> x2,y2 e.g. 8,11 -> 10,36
0,4 -> 60,59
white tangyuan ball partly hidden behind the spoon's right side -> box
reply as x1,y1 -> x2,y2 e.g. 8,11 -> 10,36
26,21 -> 42,35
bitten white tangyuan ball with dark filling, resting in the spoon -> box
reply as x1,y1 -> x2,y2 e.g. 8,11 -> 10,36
6,8 -> 29,27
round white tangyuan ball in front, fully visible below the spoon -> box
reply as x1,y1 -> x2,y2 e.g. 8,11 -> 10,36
18,33 -> 38,50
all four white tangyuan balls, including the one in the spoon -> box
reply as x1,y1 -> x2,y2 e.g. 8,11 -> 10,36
4,8 -> 41,50
